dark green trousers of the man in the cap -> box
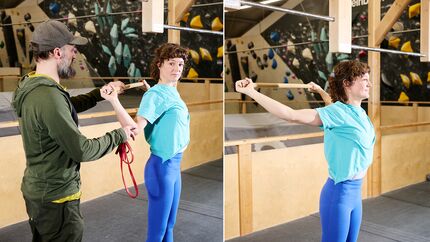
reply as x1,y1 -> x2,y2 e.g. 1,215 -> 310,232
24,198 -> 84,242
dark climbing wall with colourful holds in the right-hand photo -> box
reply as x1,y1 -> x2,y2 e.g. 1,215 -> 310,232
225,0 -> 430,107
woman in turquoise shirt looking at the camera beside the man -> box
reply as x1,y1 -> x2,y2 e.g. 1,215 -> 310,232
103,43 -> 190,242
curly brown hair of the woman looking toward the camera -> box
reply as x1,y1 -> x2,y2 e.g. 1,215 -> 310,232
150,43 -> 189,81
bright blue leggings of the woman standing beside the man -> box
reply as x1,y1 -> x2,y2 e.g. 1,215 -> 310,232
145,153 -> 182,242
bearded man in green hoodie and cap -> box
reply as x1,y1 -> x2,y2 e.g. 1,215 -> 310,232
12,20 -> 134,241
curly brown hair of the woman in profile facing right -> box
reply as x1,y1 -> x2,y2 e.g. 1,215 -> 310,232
328,60 -> 370,103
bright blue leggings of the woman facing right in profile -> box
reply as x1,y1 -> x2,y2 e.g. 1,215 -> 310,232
320,178 -> 363,242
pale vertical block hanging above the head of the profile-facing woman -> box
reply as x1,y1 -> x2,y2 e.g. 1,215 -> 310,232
329,0 -> 352,53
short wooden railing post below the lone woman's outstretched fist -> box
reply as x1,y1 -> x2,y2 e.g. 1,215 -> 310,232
237,144 -> 254,236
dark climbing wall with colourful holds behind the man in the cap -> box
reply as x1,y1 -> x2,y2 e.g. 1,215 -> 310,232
0,0 -> 223,86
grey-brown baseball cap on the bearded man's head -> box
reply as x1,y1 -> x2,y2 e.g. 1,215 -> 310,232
31,20 -> 88,51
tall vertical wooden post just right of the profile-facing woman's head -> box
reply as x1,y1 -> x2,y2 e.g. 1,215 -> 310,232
367,0 -> 382,197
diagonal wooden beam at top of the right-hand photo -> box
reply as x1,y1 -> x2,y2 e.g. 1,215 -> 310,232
369,0 -> 411,47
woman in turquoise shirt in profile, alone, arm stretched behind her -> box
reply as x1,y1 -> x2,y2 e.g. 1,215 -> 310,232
236,60 -> 375,242
